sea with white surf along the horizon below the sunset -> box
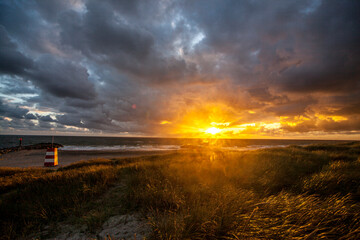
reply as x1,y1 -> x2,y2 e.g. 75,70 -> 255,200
0,135 -> 349,151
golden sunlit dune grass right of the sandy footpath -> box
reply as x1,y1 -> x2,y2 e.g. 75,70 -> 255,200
125,144 -> 360,239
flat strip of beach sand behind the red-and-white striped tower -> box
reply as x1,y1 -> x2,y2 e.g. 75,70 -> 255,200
0,149 -> 176,168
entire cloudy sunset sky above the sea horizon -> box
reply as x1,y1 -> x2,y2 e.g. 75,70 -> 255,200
0,0 -> 360,140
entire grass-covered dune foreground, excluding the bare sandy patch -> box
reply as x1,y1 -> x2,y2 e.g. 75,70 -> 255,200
0,142 -> 360,239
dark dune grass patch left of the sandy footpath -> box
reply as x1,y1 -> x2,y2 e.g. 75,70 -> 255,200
0,166 -> 119,238
